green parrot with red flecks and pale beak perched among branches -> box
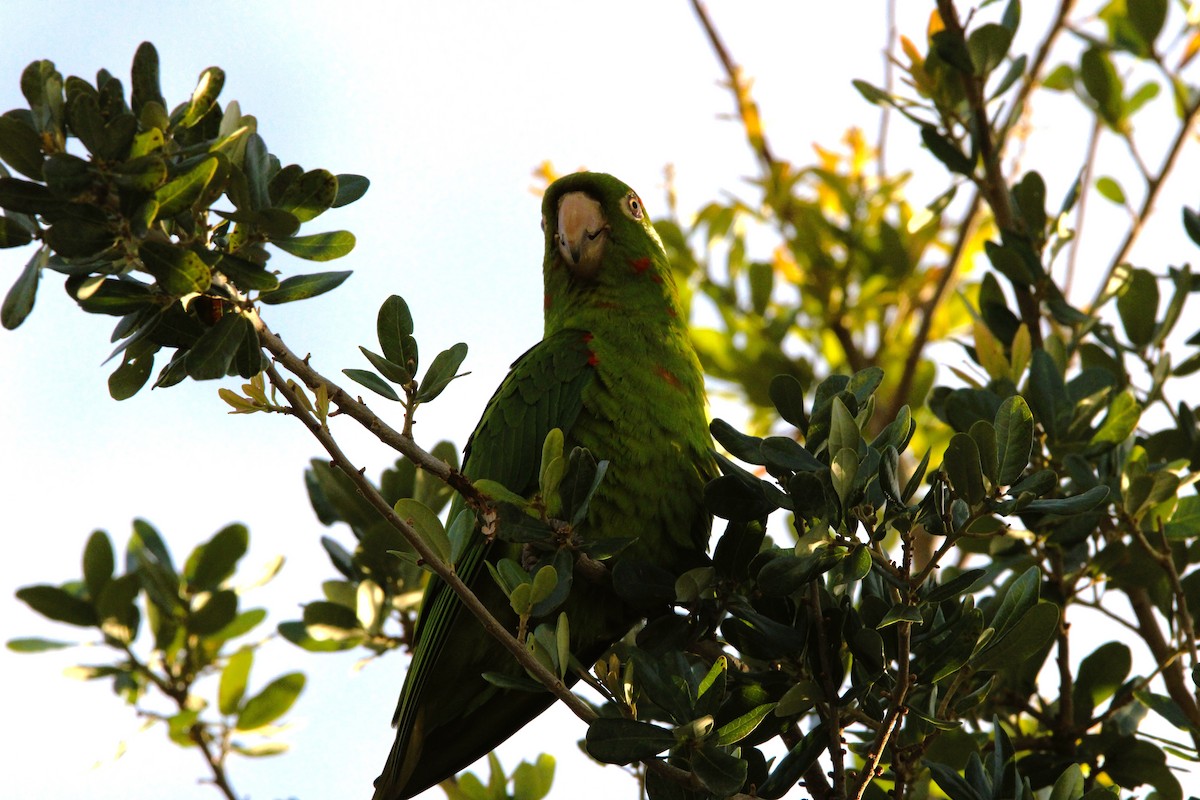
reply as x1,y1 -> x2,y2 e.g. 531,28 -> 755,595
374,173 -> 715,800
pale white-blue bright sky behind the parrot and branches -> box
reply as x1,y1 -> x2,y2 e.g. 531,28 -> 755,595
0,0 -> 1195,800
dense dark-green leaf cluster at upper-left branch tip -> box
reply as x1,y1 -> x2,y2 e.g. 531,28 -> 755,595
0,42 -> 368,399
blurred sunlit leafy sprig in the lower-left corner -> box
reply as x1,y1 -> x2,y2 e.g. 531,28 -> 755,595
8,519 -> 305,793
